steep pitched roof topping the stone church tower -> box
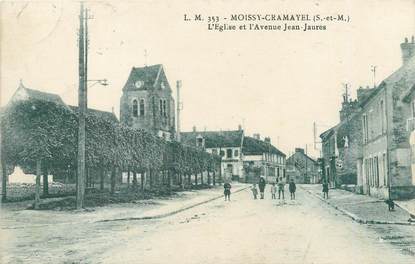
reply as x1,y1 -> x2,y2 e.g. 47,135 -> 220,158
123,64 -> 170,91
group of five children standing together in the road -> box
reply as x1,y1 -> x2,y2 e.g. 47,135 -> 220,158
251,177 -> 297,200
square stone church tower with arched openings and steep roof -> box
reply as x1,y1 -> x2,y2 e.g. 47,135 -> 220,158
120,64 -> 175,140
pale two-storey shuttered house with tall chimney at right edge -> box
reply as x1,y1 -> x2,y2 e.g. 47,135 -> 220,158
358,37 -> 415,199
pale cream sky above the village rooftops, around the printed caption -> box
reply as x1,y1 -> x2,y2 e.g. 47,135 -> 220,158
0,0 -> 415,156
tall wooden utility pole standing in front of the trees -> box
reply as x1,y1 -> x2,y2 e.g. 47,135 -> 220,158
76,2 -> 88,209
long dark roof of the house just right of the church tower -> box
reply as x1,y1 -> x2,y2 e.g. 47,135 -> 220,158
180,130 -> 243,148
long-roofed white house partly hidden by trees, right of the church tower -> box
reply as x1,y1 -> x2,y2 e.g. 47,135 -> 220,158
180,126 -> 244,181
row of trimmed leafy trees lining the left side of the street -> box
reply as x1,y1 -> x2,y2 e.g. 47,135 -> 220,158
1,99 -> 221,204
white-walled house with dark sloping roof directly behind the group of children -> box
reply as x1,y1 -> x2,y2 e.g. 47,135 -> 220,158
242,134 -> 286,183
